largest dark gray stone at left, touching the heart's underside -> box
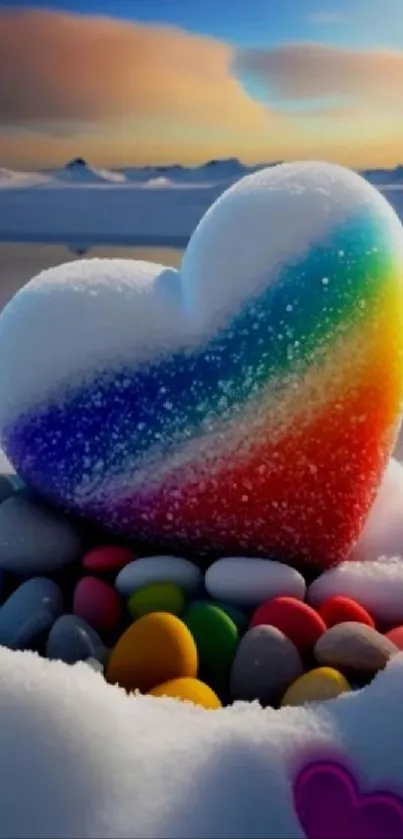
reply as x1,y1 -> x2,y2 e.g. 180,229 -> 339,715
0,493 -> 82,574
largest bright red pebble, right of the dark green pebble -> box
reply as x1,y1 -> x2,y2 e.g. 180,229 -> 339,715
250,597 -> 326,652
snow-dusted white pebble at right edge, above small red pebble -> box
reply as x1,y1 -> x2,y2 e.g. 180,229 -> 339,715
308,557 -> 403,624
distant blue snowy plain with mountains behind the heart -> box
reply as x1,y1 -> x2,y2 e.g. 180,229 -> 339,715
0,158 -> 403,250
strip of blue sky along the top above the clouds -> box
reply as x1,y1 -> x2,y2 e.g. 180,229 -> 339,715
4,0 -> 403,48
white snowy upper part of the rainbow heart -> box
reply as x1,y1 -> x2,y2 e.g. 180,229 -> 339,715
0,162 -> 403,428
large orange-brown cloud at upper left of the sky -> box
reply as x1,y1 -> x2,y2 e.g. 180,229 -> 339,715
0,10 -> 275,135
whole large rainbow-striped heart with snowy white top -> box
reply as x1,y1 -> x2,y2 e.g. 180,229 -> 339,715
0,163 -> 403,566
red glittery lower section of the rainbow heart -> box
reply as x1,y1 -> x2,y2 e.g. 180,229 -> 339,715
124,380 -> 396,568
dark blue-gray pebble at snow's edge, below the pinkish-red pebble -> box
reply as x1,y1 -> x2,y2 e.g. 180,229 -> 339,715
46,615 -> 107,664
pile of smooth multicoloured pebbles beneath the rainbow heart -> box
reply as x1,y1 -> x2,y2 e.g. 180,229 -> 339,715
0,475 -> 403,709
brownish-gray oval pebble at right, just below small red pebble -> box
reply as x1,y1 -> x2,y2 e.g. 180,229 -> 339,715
314,621 -> 399,673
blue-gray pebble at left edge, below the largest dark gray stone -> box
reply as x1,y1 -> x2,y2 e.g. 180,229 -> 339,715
0,577 -> 63,650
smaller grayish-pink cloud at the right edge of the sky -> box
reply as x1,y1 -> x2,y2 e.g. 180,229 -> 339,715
236,44 -> 403,112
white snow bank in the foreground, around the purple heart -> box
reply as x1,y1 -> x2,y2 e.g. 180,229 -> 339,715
0,648 -> 403,839
